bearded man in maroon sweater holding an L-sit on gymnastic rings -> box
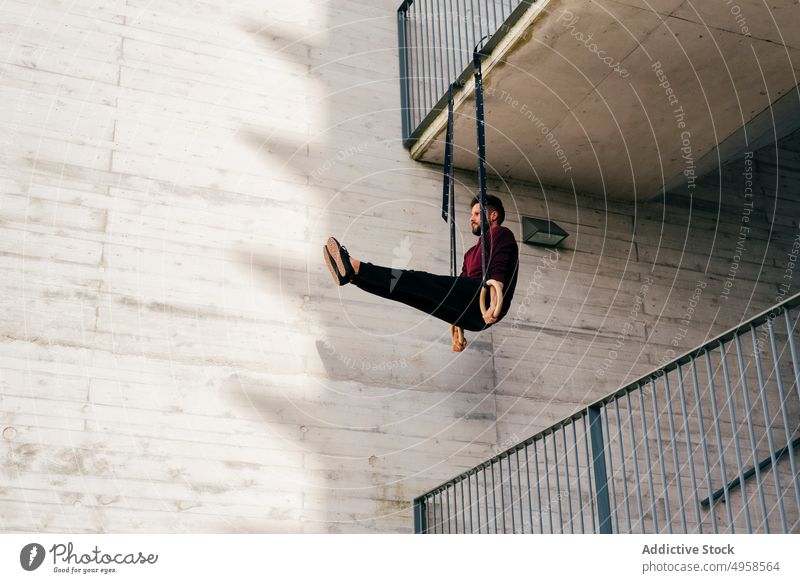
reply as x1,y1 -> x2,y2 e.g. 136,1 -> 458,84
322,195 -> 519,352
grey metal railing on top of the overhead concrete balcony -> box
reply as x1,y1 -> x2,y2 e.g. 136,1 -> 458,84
397,0 -> 534,147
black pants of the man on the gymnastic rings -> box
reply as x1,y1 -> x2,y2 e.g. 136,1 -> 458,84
353,261 -> 489,332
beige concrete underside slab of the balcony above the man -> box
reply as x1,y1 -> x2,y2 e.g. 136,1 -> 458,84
411,0 -> 800,200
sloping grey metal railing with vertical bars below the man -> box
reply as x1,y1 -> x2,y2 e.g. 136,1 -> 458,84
414,294 -> 800,533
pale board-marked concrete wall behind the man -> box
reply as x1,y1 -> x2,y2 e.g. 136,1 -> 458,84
0,0 -> 800,532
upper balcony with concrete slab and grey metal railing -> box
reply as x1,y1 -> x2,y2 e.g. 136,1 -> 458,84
398,0 -> 800,201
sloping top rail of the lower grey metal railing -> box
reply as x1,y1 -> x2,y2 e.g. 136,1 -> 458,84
415,292 -> 800,500
